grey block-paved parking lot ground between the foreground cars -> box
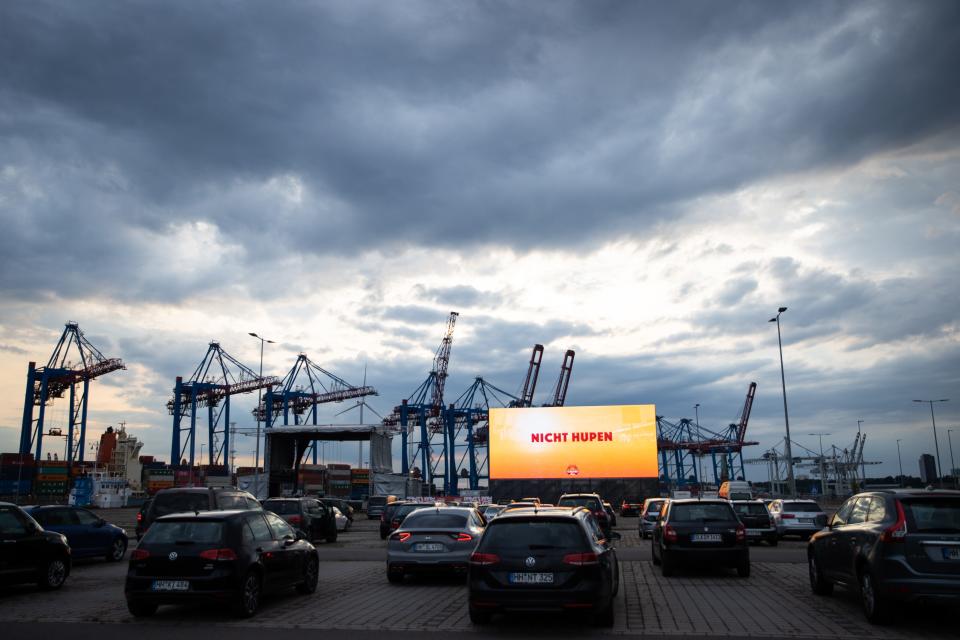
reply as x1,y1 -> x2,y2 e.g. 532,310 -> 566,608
0,510 -> 957,640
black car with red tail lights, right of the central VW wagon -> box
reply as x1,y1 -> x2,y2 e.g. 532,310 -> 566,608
650,499 -> 750,578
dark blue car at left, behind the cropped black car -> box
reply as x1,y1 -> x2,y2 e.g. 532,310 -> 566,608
25,505 -> 127,562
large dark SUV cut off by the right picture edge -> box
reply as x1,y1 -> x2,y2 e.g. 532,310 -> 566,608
807,489 -> 960,623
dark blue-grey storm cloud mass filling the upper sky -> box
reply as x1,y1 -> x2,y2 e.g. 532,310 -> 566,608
0,2 -> 960,299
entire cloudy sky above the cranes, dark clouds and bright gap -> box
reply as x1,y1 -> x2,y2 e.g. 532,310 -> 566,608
0,0 -> 960,479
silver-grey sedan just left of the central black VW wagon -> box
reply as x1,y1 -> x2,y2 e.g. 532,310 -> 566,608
387,507 -> 484,583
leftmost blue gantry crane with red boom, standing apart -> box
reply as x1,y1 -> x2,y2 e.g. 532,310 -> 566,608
20,322 -> 127,463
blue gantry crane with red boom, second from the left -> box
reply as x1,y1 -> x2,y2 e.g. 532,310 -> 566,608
167,342 -> 280,467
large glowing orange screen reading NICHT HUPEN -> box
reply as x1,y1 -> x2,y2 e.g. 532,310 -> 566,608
489,404 -> 657,480
